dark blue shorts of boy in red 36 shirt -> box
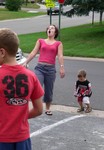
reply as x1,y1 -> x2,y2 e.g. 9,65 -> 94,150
0,138 -> 32,150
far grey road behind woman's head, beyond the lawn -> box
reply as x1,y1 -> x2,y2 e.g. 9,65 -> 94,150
0,14 -> 99,34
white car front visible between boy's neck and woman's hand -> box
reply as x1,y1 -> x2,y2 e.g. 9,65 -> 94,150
16,48 -> 26,65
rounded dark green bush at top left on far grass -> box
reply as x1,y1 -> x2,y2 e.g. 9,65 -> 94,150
5,0 -> 22,11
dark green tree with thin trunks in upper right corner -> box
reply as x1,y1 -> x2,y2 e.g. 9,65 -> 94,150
65,0 -> 104,24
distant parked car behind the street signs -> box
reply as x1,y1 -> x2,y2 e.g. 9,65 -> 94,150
47,2 -> 63,15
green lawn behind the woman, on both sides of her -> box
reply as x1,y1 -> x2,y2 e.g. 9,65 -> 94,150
19,24 -> 104,58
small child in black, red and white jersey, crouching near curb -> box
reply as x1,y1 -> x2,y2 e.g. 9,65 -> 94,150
74,70 -> 92,113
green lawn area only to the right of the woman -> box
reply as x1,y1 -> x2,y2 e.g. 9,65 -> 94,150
62,25 -> 104,58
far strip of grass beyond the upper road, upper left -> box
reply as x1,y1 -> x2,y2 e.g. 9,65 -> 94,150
0,8 -> 46,20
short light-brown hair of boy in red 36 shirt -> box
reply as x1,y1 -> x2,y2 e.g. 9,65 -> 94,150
0,28 -> 19,56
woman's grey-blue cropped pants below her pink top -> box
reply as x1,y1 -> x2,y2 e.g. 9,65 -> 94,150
35,64 -> 56,102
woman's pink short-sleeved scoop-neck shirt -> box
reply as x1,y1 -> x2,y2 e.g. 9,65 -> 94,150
38,39 -> 61,64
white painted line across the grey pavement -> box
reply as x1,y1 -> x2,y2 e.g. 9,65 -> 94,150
30,115 -> 86,137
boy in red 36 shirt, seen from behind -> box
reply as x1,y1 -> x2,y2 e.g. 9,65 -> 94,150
0,28 -> 44,150
